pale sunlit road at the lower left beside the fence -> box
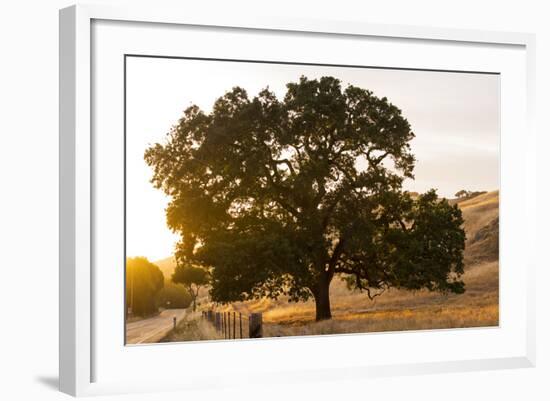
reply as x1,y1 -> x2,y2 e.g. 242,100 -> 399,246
126,309 -> 187,344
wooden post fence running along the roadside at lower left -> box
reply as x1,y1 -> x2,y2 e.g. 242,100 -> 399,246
202,310 -> 263,339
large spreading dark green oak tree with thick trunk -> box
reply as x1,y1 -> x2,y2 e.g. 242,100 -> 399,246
145,77 -> 465,320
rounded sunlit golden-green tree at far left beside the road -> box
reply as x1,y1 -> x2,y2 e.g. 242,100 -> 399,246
126,257 -> 164,316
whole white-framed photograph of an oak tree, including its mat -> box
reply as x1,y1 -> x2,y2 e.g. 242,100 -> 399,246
60,6 -> 536,395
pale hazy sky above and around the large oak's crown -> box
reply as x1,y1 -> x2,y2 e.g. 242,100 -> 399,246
126,57 -> 500,261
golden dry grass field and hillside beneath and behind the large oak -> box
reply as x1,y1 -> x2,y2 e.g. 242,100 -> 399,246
157,191 -> 499,341
